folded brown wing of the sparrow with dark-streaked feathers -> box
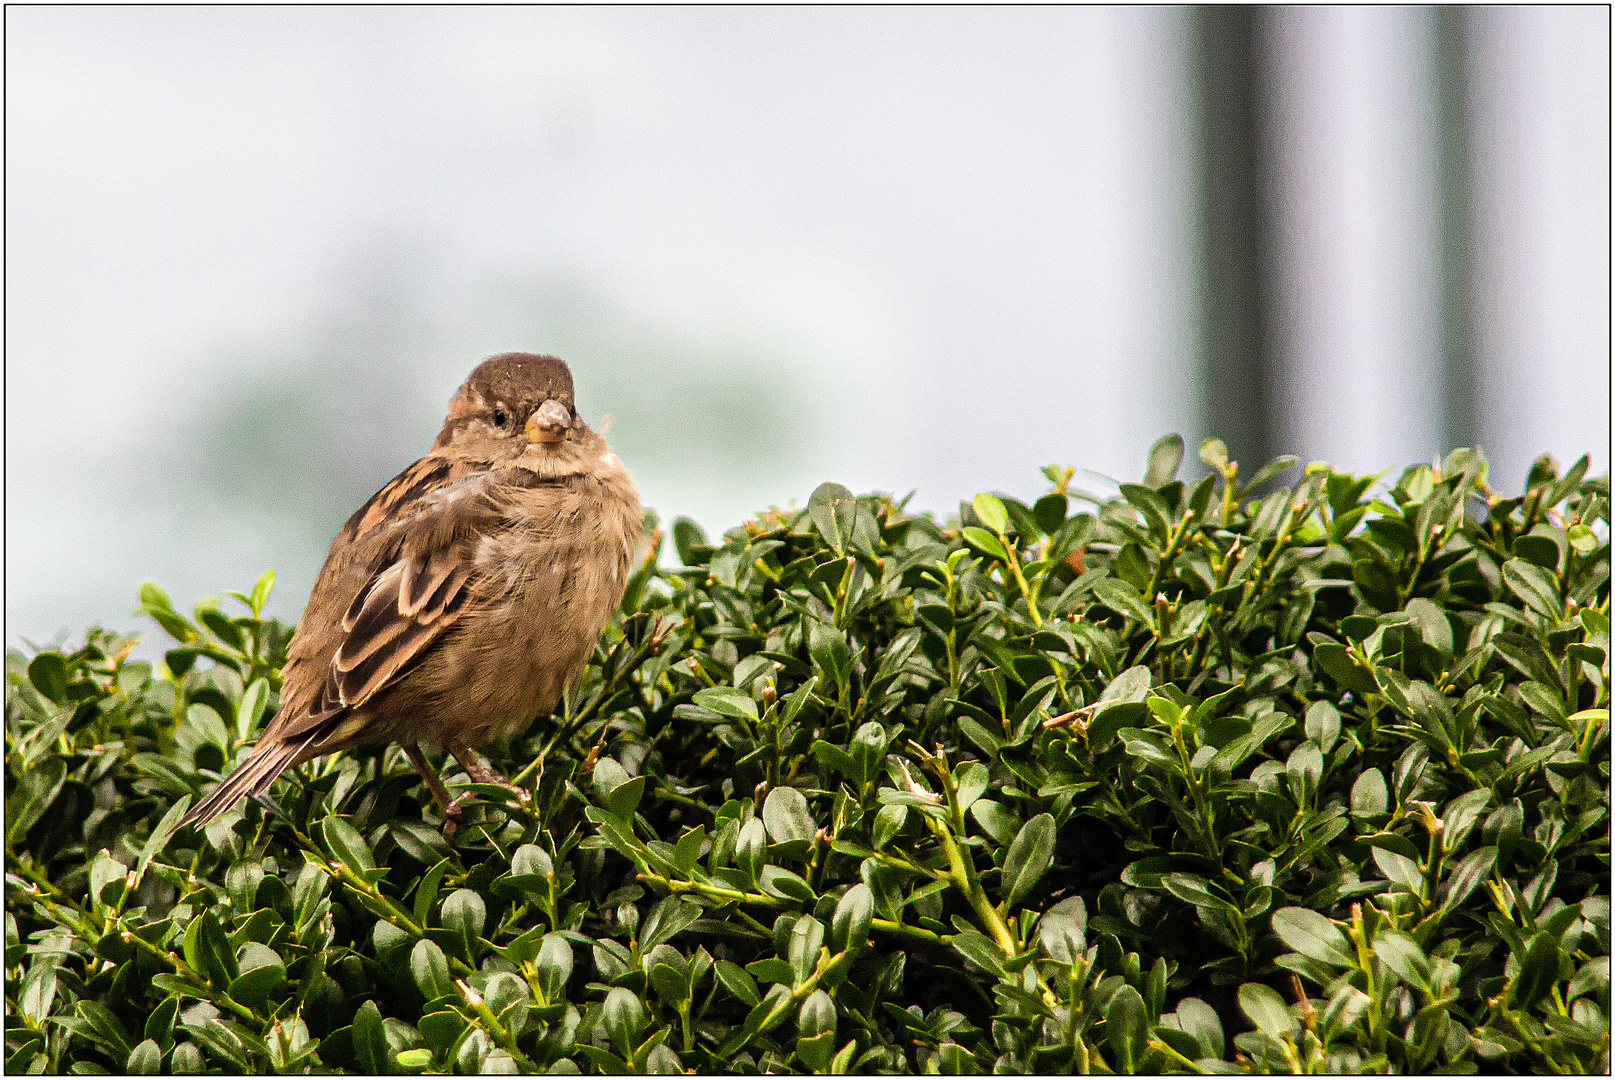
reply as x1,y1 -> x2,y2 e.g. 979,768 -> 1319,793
276,457 -> 504,739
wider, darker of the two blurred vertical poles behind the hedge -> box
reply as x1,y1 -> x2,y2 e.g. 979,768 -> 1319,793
1193,5 -> 1277,476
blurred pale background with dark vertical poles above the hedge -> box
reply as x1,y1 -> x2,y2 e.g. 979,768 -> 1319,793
5,6 -> 1610,644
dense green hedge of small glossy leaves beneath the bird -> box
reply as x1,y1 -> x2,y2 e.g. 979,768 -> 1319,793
6,436 -> 1610,1074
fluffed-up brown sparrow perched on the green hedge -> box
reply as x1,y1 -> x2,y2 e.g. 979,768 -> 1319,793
182,352 -> 640,835
